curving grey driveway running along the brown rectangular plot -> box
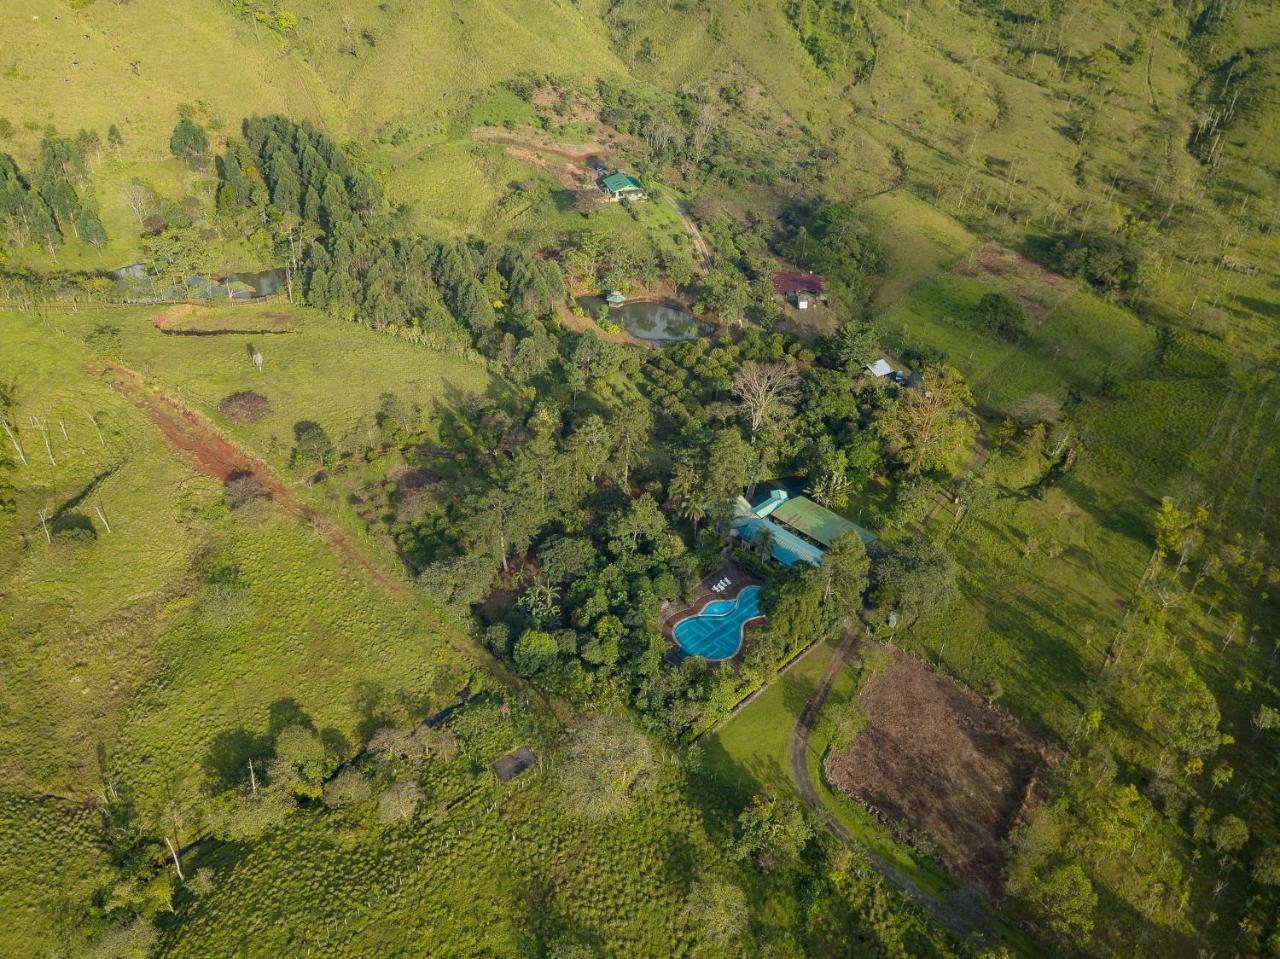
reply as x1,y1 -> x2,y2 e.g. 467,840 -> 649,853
791,633 -> 992,937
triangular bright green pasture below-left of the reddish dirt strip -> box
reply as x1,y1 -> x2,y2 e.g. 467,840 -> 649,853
0,307 -> 467,808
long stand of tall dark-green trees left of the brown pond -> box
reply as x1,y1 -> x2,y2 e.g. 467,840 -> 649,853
218,117 -> 564,358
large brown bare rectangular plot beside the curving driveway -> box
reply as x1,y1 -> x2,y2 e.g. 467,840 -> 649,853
823,648 -> 1055,898
